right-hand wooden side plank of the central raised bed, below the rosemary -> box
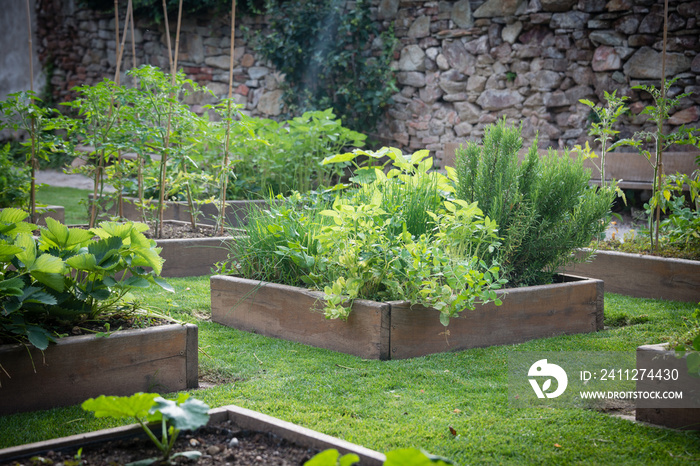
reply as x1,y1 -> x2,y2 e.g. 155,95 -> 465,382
390,279 -> 603,359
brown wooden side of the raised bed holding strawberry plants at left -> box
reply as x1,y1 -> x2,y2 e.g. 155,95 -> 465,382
0,324 -> 198,415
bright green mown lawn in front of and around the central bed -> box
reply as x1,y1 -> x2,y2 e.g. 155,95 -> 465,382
0,277 -> 700,465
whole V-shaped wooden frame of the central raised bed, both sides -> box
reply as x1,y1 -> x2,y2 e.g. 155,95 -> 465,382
211,275 -> 603,360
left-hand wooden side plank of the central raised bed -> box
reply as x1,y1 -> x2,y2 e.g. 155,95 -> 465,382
211,275 -> 391,359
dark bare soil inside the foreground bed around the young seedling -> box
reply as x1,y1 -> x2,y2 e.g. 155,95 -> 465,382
2,421 -> 317,466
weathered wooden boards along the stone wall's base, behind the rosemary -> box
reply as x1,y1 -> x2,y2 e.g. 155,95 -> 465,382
443,143 -> 700,189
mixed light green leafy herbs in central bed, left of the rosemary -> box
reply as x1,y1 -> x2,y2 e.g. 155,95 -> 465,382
226,148 -> 504,325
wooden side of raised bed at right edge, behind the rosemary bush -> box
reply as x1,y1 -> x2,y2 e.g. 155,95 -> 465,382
564,250 -> 700,303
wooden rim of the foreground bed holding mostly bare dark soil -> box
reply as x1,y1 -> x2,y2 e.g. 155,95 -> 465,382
0,405 -> 386,466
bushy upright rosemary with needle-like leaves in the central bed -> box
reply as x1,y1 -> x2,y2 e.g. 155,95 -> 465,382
455,120 -> 615,286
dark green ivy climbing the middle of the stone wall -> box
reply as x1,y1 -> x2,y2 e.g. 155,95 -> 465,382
253,0 -> 398,132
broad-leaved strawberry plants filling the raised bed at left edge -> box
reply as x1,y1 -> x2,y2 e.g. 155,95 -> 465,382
0,209 -> 172,350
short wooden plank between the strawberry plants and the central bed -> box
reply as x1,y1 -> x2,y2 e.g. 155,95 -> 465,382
156,237 -> 234,277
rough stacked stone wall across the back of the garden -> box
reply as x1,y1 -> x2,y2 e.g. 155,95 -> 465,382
37,0 -> 700,167
